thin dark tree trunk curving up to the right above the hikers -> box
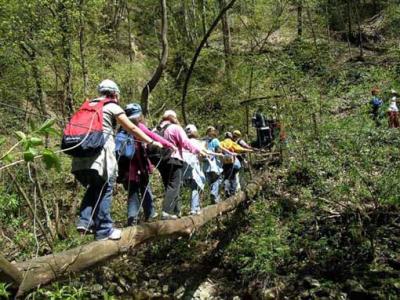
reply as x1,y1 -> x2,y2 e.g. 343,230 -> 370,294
181,0 -> 236,124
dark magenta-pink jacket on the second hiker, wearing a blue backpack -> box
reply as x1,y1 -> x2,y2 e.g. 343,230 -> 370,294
129,123 -> 173,182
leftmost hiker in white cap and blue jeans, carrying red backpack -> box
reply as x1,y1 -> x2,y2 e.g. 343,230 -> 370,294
68,79 -> 162,240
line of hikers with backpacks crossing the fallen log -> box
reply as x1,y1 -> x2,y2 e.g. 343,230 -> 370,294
62,79 -> 255,240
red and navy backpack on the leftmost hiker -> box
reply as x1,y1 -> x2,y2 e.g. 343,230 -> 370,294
61,98 -> 115,157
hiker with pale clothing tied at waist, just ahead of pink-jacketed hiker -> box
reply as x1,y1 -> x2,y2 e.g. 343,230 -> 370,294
183,124 -> 206,215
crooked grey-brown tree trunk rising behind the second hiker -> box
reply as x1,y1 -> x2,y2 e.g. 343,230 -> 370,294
141,0 -> 168,115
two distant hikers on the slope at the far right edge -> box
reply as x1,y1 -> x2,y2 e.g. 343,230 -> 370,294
370,87 -> 400,128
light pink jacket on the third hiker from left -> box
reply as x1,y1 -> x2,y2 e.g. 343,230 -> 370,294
160,121 -> 201,161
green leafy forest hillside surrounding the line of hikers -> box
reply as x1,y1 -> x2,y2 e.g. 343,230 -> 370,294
0,0 -> 400,298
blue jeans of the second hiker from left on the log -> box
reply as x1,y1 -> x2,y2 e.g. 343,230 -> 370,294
128,181 -> 155,220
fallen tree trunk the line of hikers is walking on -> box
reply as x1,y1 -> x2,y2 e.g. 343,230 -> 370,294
15,169 -> 268,296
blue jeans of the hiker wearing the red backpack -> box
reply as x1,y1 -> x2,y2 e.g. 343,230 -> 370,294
75,170 -> 114,239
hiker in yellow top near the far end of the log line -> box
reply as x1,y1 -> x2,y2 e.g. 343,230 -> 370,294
221,132 -> 253,197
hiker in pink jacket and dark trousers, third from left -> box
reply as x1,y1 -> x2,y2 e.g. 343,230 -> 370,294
158,110 -> 207,220
